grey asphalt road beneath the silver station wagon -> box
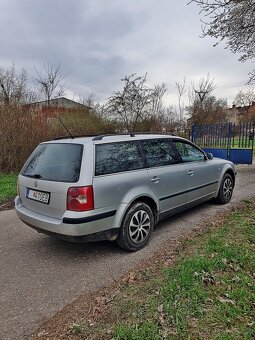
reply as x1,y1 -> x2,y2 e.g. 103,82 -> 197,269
0,166 -> 255,340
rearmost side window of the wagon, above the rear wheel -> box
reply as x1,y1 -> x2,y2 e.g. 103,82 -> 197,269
96,142 -> 144,175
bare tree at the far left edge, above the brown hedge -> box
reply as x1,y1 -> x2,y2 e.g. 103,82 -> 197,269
0,64 -> 29,105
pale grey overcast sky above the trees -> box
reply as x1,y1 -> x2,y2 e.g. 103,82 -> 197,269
0,0 -> 254,105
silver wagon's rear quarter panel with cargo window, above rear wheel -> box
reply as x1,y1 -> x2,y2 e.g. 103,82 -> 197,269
93,141 -> 149,209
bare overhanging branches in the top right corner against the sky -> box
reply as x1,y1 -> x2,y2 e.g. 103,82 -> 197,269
189,0 -> 255,82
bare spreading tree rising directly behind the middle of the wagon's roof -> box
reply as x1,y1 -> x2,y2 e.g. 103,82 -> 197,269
106,74 -> 161,131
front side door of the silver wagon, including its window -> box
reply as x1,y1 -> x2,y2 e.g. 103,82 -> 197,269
173,140 -> 220,203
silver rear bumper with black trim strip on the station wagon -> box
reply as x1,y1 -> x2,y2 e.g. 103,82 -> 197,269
15,196 -> 119,242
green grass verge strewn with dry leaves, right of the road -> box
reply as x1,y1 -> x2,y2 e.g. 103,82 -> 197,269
72,200 -> 255,340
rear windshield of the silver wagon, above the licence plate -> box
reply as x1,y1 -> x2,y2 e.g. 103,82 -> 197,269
21,143 -> 83,183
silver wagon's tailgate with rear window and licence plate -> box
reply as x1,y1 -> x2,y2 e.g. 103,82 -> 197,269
19,143 -> 83,218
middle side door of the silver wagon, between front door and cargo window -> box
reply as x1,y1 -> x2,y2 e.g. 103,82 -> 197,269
140,139 -> 188,215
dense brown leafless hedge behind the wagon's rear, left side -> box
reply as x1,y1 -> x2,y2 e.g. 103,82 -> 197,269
0,105 -> 115,173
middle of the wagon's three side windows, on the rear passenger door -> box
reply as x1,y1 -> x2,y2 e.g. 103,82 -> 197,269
141,140 -> 179,167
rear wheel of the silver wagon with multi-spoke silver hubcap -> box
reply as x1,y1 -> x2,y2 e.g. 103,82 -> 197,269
116,202 -> 155,251
